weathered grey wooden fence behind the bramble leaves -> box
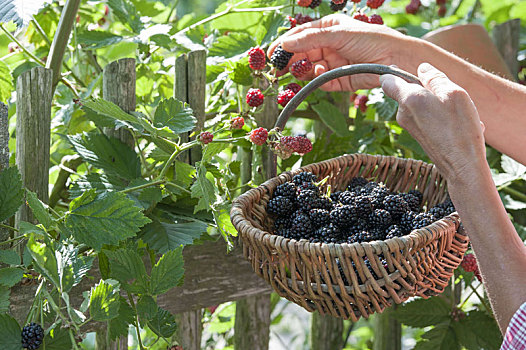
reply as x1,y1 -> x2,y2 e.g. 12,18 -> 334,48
0,21 -> 518,350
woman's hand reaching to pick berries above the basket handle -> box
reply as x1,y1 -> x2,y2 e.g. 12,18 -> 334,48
268,14 -> 415,91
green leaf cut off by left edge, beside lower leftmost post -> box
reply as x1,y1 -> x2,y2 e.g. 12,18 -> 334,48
0,167 -> 24,222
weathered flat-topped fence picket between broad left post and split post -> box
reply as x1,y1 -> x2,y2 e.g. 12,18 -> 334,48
102,58 -> 136,147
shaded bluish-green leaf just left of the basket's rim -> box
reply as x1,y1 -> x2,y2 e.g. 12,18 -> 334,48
141,219 -> 207,254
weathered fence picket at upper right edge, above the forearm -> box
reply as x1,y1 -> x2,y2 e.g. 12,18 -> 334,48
492,18 -> 521,80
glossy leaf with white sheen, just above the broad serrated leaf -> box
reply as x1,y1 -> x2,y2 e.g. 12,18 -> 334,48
68,133 -> 141,180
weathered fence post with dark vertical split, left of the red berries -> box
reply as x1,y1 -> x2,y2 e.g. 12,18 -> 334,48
174,50 -> 206,350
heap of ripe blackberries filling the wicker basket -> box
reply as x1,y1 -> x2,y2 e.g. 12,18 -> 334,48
267,172 -> 455,243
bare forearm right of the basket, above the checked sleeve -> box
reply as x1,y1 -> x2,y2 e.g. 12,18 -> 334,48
448,164 -> 526,333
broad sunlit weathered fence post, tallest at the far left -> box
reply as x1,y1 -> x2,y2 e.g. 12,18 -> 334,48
15,67 -> 53,228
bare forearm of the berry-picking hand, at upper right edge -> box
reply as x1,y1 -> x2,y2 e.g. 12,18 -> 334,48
396,39 -> 526,164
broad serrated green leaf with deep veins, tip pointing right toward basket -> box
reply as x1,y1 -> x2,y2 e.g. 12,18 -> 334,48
64,190 -> 151,251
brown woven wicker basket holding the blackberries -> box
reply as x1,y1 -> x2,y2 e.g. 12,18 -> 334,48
231,66 -> 468,321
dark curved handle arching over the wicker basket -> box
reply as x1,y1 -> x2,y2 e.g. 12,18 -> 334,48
270,63 -> 421,177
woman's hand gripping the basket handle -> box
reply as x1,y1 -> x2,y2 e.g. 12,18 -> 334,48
380,63 -> 487,181
